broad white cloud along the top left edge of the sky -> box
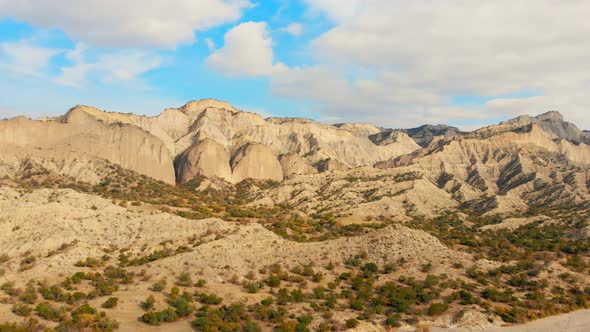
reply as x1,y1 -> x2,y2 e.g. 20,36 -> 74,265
0,0 -> 251,48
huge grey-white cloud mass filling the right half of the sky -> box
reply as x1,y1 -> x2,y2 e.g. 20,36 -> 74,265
273,0 -> 590,127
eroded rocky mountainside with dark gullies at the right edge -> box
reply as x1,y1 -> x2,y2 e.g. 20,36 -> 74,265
376,118 -> 590,213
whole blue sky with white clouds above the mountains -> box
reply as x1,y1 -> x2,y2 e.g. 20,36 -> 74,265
0,0 -> 590,129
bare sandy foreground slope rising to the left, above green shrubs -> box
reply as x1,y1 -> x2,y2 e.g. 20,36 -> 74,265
0,187 -> 493,331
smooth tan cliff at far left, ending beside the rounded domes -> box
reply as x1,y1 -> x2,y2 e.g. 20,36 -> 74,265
0,107 -> 174,183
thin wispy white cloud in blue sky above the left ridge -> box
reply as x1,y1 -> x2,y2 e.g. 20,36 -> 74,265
55,44 -> 162,87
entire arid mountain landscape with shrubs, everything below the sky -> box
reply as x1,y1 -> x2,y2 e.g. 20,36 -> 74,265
0,100 -> 590,331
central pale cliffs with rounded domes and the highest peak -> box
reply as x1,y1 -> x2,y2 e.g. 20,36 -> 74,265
97,99 -> 420,183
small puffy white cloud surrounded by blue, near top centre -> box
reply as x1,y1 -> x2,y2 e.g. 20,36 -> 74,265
206,22 -> 284,77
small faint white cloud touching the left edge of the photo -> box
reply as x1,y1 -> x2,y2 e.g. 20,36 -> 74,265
0,39 -> 63,75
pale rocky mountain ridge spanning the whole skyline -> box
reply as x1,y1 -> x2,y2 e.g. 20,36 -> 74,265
0,99 -> 590,187
